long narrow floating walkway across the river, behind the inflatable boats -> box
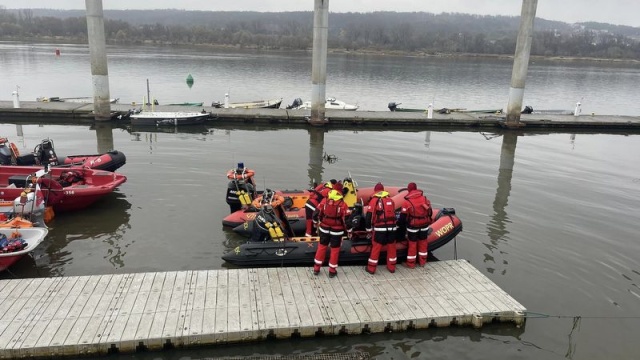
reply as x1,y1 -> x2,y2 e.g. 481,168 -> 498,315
0,100 -> 640,131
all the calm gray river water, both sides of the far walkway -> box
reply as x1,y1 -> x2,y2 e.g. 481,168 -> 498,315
0,44 -> 640,360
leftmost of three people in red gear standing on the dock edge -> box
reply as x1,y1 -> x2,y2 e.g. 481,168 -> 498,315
313,182 -> 349,277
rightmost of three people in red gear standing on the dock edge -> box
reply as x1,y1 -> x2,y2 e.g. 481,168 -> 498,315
398,182 -> 433,269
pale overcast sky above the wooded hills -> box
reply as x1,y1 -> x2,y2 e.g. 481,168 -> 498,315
0,0 -> 640,27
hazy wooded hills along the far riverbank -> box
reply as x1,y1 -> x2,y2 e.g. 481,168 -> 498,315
0,7 -> 640,60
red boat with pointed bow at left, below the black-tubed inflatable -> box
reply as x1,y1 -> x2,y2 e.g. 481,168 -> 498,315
0,166 -> 127,212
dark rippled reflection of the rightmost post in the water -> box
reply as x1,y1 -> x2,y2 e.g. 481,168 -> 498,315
484,132 -> 518,275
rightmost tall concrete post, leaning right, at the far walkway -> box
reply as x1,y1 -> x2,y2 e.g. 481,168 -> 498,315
506,0 -> 538,127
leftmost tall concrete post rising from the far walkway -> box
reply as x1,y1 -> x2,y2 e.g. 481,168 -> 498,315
85,0 -> 111,120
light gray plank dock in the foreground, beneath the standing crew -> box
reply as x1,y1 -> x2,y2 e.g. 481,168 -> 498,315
0,260 -> 526,359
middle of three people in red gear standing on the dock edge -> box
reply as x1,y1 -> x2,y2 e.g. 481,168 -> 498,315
365,183 -> 398,275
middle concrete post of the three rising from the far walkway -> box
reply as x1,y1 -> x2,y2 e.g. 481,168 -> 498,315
310,0 -> 329,125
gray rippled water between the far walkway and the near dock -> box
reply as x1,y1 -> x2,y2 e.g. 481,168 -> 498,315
0,124 -> 640,359
